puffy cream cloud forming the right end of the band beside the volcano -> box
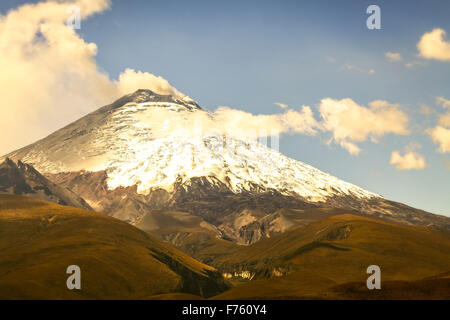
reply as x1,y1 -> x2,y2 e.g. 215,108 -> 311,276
319,98 -> 409,155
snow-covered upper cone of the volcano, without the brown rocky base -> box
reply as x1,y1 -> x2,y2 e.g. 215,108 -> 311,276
2,90 -> 377,202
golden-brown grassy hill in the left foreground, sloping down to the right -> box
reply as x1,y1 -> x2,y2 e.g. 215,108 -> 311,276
0,195 -> 227,299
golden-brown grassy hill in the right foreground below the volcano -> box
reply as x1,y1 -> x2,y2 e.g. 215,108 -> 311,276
208,214 -> 450,299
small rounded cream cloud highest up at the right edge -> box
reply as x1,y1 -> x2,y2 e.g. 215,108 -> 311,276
417,28 -> 450,61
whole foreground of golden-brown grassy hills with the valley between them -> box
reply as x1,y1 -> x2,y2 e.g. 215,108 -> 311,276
0,194 -> 450,299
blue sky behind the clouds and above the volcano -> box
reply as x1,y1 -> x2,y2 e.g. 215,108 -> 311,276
0,0 -> 450,216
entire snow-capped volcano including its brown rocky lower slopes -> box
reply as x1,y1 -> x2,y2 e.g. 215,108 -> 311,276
0,90 -> 450,244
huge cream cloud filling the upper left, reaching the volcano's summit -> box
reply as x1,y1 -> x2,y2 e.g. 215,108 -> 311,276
0,0 -> 185,154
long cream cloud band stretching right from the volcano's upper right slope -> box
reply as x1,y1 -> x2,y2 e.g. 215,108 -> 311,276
207,98 -> 416,155
